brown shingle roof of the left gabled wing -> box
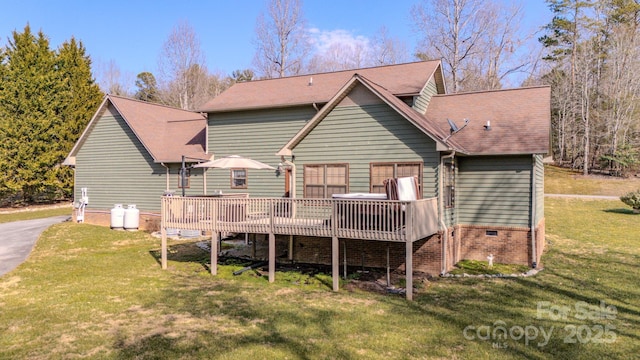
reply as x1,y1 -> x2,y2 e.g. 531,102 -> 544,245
65,95 -> 206,165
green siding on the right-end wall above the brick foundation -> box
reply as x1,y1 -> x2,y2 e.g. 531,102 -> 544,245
456,156 -> 532,227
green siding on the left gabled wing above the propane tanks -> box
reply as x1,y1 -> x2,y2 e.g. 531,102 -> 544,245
74,104 -> 202,212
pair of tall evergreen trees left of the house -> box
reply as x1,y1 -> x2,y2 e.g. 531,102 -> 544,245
0,25 -> 101,203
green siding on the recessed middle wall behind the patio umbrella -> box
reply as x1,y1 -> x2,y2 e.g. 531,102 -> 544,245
207,106 -> 316,197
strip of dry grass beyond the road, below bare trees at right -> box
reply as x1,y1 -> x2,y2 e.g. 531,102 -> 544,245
544,165 -> 640,196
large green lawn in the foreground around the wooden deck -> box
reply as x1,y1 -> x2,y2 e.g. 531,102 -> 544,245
0,199 -> 640,359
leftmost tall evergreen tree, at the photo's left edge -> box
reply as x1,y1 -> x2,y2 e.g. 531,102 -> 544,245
0,25 -> 59,201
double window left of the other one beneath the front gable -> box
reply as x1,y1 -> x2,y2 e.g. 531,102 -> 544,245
303,164 -> 349,199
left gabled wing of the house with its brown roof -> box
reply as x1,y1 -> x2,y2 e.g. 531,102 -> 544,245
65,95 -> 207,222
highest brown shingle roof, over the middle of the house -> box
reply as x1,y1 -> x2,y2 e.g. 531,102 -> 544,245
202,60 -> 440,112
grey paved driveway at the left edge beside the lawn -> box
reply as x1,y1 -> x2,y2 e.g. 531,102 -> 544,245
0,215 -> 69,276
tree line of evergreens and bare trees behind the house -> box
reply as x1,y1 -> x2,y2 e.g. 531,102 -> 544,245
0,0 -> 640,202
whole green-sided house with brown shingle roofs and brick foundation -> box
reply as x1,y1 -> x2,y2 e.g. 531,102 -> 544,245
67,61 -> 550,286
